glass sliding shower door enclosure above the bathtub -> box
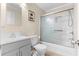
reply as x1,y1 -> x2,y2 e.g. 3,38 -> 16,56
40,10 -> 74,47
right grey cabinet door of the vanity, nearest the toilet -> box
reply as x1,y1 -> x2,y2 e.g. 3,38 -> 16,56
20,45 -> 31,56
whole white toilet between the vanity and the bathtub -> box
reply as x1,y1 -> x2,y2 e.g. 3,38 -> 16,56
31,36 -> 47,56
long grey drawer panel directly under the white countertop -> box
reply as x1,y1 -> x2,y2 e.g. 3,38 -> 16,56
1,39 -> 31,53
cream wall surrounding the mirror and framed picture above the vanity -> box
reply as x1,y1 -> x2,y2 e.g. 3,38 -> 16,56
0,3 -> 44,35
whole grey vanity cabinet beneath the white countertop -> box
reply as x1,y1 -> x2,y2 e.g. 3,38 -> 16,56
1,39 -> 31,56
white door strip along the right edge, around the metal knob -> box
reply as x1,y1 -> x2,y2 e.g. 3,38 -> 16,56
74,3 -> 79,56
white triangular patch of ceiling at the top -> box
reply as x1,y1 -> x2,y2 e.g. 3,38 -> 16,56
36,3 -> 66,12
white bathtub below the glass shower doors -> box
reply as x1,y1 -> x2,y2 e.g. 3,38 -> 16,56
42,42 -> 77,56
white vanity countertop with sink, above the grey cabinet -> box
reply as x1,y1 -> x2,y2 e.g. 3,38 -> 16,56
0,35 -> 36,45
